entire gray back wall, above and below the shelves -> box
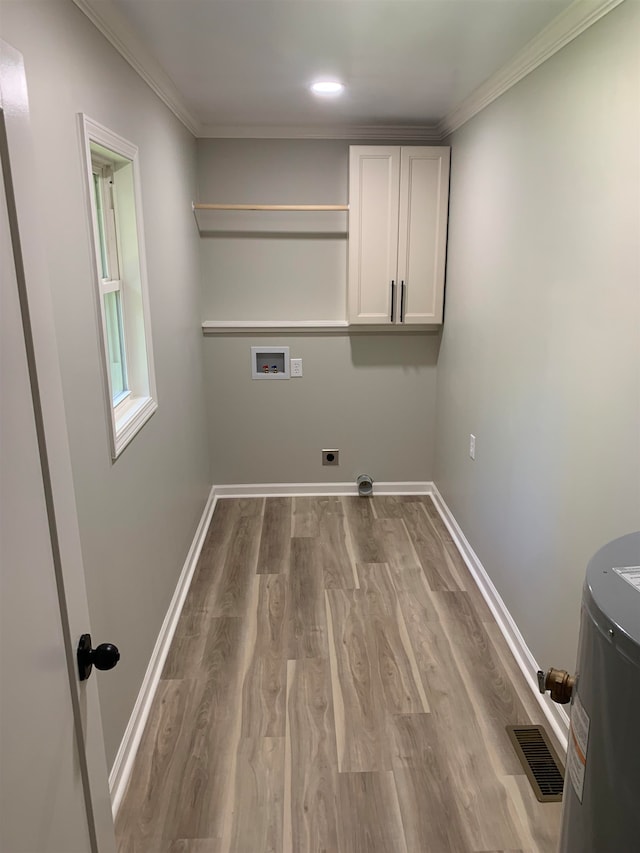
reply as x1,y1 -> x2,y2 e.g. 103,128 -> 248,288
198,140 -> 439,484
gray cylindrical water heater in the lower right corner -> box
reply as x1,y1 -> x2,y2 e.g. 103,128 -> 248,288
560,533 -> 640,853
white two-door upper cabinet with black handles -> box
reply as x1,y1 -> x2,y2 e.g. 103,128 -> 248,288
348,145 -> 450,325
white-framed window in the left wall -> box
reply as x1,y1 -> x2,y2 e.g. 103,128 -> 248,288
81,116 -> 158,459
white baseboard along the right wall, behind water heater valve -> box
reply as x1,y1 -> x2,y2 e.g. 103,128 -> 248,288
431,485 -> 569,752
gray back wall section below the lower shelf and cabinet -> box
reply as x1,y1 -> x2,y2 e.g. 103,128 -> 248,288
205,333 -> 439,484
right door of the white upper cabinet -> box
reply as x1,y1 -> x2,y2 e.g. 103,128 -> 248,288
398,147 -> 450,324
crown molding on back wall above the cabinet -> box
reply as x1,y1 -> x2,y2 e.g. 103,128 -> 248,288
199,125 -> 441,142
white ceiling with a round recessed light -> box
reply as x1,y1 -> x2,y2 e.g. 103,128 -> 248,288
104,0 -> 570,135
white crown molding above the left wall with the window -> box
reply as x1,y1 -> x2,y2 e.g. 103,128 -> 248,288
73,0 -> 200,137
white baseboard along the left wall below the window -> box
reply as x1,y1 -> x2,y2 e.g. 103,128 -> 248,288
109,487 -> 217,819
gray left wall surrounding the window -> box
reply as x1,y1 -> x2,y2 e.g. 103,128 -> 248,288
0,0 -> 211,762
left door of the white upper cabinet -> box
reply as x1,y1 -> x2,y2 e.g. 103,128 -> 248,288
349,145 -> 400,323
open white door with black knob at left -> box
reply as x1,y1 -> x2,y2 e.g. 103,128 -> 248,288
0,42 -> 115,853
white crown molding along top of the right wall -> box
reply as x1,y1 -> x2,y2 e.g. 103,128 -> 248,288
437,0 -> 624,139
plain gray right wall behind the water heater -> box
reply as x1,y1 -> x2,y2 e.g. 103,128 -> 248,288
435,2 -> 640,667
